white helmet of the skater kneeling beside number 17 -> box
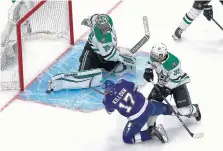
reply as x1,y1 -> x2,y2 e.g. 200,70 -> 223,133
150,43 -> 168,62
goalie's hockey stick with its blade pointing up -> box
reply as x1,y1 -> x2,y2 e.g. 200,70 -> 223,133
100,16 -> 150,83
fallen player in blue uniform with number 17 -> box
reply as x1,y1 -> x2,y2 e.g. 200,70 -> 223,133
103,79 -> 172,144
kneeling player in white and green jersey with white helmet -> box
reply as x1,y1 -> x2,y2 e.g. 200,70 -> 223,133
144,43 -> 201,121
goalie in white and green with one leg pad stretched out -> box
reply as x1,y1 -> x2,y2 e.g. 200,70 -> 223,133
46,14 -> 136,93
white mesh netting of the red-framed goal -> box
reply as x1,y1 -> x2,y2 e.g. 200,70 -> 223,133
0,0 -> 70,90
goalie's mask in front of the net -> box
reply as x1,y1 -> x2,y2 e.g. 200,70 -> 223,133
95,15 -> 112,34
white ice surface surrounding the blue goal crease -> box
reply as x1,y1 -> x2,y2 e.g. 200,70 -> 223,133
0,0 -> 223,151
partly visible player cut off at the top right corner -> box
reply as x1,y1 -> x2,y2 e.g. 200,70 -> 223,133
172,0 -> 223,40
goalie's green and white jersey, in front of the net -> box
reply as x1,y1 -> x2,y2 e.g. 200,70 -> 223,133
88,15 -> 119,61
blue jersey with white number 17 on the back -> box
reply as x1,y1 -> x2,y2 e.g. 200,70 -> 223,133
103,79 -> 145,118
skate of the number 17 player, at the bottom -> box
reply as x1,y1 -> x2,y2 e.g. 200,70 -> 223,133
148,124 -> 168,143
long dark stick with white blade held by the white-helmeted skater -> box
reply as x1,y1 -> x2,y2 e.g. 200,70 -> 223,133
150,79 -> 204,139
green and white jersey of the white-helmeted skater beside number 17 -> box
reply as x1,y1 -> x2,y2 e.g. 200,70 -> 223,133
147,53 -> 190,89
